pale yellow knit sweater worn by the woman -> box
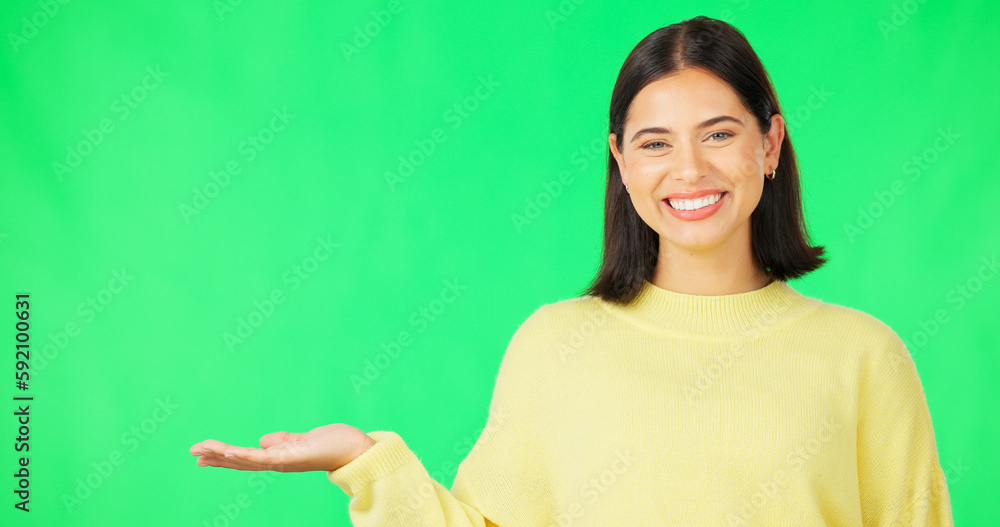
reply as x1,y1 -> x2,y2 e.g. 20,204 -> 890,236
328,281 -> 952,527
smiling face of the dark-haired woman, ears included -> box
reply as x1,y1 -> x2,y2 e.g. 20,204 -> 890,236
608,68 -> 784,254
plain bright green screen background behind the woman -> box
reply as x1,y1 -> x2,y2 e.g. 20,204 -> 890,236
0,0 -> 1000,526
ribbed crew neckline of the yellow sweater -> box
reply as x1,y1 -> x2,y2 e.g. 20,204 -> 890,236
601,280 -> 821,337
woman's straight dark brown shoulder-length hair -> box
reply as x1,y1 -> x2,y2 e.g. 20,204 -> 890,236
583,16 -> 826,304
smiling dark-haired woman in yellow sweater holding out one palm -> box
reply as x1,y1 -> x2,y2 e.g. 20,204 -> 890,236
191,17 -> 952,527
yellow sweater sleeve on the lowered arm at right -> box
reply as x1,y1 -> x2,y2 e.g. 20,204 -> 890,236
857,326 -> 953,527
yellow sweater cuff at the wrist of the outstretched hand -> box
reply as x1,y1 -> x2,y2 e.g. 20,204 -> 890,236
327,430 -> 420,498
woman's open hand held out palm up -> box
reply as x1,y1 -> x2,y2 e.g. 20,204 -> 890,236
191,423 -> 375,472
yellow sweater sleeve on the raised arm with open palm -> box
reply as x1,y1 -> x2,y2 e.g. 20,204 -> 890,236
328,308 -> 551,527
